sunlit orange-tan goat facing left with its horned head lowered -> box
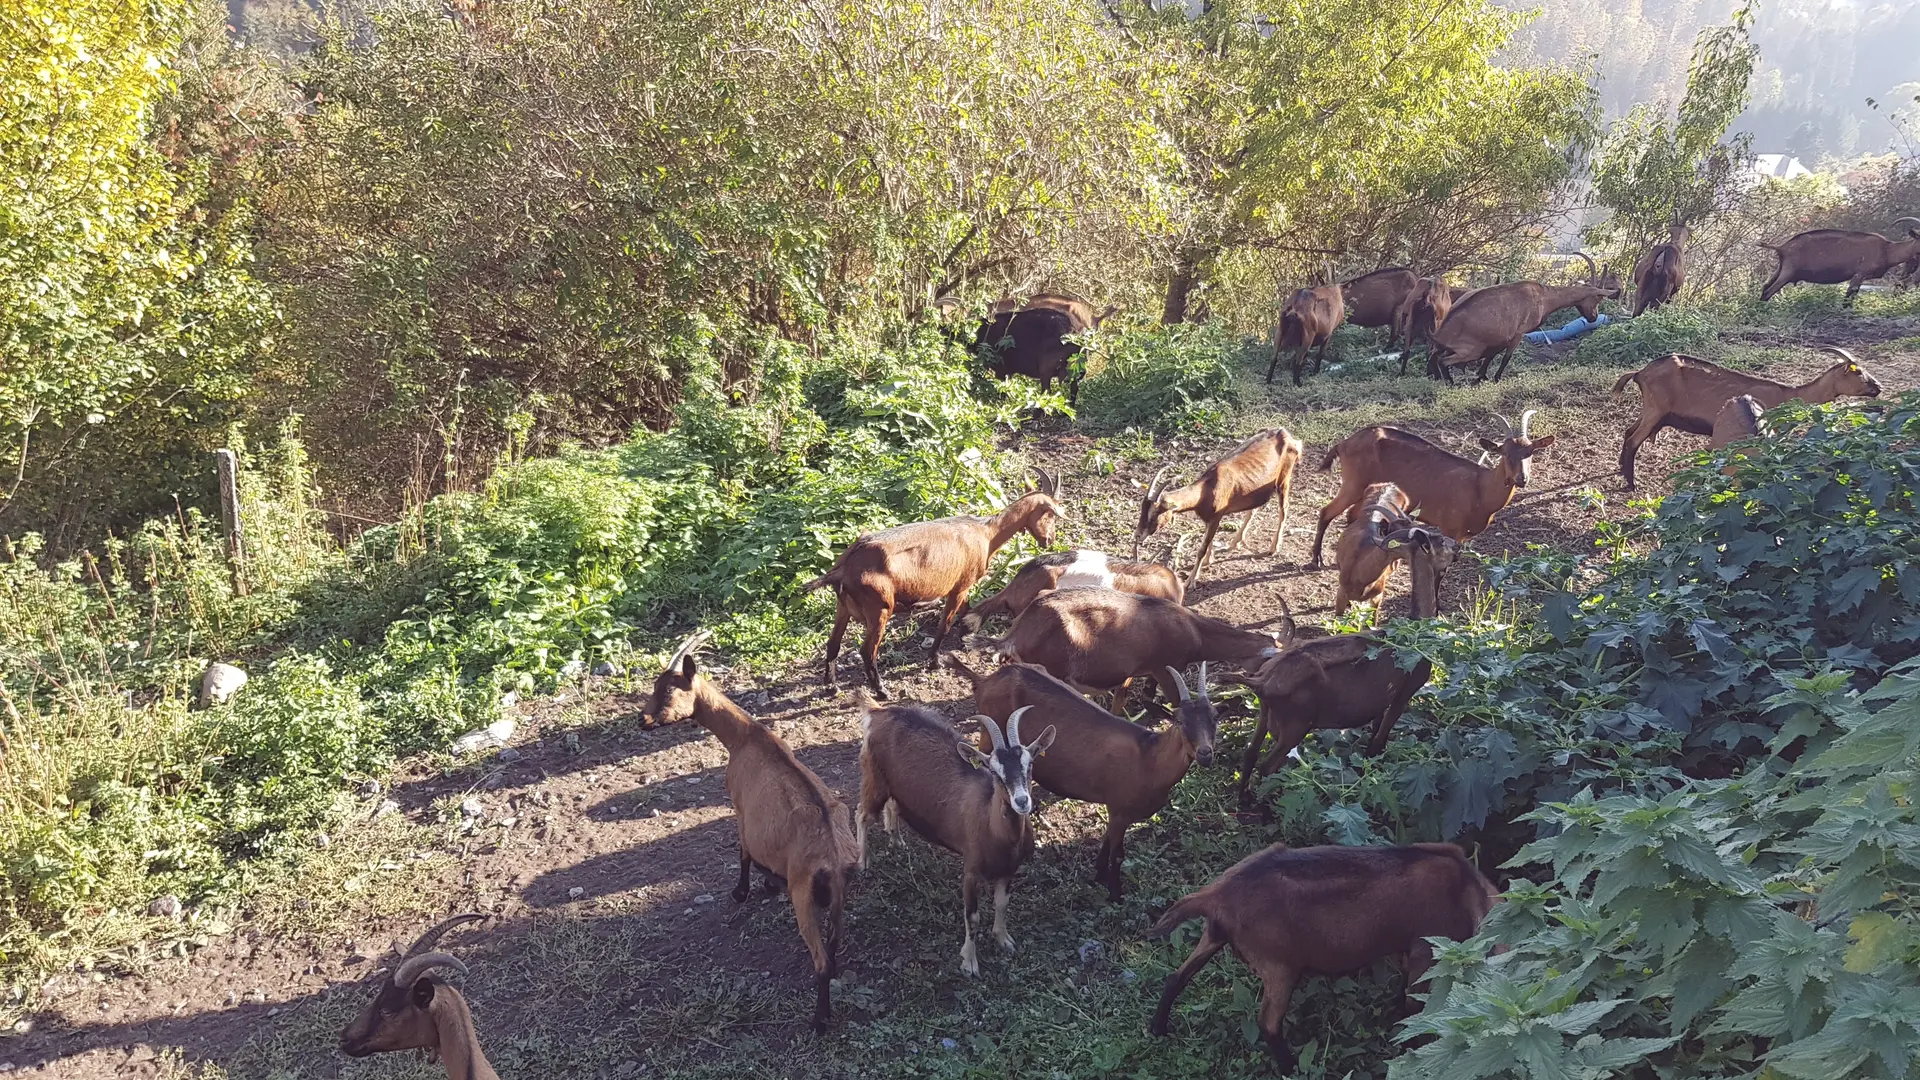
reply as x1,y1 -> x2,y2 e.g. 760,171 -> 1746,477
1133,427 -> 1304,588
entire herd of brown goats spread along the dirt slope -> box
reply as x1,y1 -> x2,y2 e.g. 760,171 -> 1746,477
330,219 -> 1920,1080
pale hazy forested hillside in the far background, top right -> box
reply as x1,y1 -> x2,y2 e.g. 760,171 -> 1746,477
1498,0 -> 1920,165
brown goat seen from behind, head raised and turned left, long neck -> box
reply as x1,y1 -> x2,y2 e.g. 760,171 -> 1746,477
643,630 -> 858,1032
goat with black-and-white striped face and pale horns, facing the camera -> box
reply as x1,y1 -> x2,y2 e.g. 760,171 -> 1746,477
856,705 -> 1054,974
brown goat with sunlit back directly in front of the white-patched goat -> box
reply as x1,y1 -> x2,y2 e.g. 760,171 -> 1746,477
993,588 -> 1292,713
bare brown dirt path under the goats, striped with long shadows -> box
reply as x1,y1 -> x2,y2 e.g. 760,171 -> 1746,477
18,338 -> 1920,1080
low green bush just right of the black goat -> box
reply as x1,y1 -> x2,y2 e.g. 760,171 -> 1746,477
1079,321 -> 1254,434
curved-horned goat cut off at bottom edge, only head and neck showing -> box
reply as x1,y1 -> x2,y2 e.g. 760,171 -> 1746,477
340,913 -> 499,1080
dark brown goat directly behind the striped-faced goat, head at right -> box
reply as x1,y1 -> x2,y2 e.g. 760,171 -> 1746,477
947,655 -> 1219,901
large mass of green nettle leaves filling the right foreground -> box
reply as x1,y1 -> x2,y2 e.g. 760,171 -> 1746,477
1390,394 -> 1920,1080
